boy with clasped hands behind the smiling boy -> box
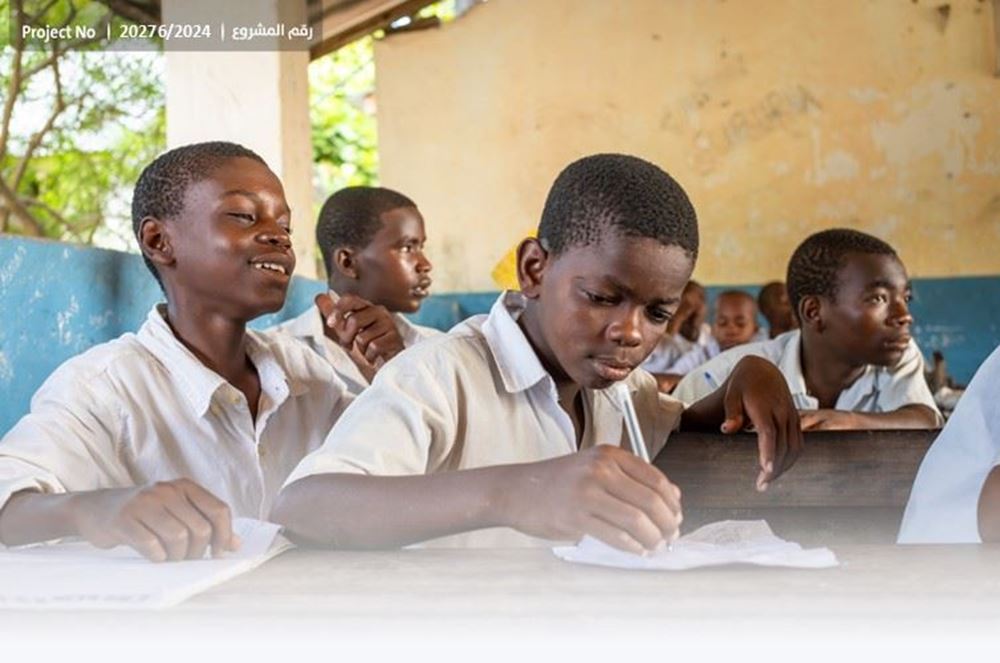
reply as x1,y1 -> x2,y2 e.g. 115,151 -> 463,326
278,186 -> 441,395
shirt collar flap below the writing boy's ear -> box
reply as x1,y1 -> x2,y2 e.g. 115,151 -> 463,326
482,290 -> 552,393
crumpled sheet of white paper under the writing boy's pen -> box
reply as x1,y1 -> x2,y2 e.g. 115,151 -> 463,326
552,520 -> 838,571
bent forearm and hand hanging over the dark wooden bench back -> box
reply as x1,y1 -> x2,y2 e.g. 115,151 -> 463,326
681,355 -> 802,490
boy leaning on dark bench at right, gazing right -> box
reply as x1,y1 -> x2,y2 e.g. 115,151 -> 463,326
674,229 -> 942,430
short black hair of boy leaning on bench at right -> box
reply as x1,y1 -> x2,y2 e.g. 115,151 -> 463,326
785,228 -> 896,322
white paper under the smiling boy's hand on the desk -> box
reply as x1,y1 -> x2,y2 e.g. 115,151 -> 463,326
0,518 -> 291,610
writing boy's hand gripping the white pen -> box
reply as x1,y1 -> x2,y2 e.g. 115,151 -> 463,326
508,444 -> 682,554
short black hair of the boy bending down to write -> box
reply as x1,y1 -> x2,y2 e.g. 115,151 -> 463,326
538,154 -> 698,260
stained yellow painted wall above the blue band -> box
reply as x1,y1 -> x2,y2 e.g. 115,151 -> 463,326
376,0 -> 1000,292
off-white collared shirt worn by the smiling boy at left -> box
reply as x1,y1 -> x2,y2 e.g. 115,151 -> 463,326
0,308 -> 352,518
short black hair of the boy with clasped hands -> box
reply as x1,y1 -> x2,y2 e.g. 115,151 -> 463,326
316,186 -> 416,276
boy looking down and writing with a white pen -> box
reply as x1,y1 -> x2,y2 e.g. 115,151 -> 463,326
272,154 -> 801,552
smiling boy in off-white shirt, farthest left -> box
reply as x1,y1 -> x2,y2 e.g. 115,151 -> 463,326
0,142 -> 352,561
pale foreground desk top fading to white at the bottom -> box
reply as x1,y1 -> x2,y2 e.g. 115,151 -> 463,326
0,545 -> 1000,663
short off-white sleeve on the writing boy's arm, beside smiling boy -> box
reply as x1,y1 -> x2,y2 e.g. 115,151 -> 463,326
285,353 -> 459,486
